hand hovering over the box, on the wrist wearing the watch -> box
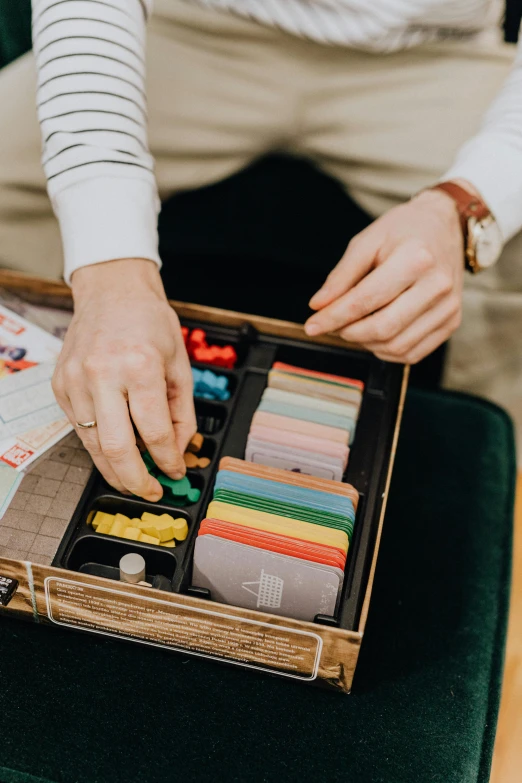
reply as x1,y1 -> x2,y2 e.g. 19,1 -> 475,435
305,183 -> 469,364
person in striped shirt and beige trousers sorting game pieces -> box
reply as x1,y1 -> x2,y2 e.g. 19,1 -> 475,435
0,0 -> 522,500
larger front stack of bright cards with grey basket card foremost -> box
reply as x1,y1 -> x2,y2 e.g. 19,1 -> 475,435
192,457 -> 359,621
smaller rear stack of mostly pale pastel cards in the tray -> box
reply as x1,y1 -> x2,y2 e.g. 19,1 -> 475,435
245,362 -> 364,481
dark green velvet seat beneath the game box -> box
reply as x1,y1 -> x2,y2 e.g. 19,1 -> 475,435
0,390 -> 515,783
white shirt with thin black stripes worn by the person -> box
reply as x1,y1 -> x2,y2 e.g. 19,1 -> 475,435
33,0 -> 522,280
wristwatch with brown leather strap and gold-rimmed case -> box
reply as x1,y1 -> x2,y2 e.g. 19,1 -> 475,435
430,182 -> 503,273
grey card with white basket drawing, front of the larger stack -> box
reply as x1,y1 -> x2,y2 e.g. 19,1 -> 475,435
193,535 -> 343,622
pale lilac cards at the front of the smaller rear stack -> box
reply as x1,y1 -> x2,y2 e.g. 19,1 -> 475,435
245,438 -> 344,481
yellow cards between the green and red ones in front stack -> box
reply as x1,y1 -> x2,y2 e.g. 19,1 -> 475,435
207,500 -> 349,552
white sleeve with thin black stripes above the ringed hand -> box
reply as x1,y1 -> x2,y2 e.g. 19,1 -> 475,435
33,0 -> 160,282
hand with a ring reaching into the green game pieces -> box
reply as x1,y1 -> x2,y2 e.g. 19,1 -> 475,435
53,259 -> 196,501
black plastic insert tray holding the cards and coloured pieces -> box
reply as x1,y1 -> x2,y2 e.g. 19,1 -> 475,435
53,321 -> 403,630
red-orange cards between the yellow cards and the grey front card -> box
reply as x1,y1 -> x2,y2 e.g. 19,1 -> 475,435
198,519 -> 346,571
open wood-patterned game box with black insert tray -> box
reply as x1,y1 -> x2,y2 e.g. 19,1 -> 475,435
0,271 -> 408,693
